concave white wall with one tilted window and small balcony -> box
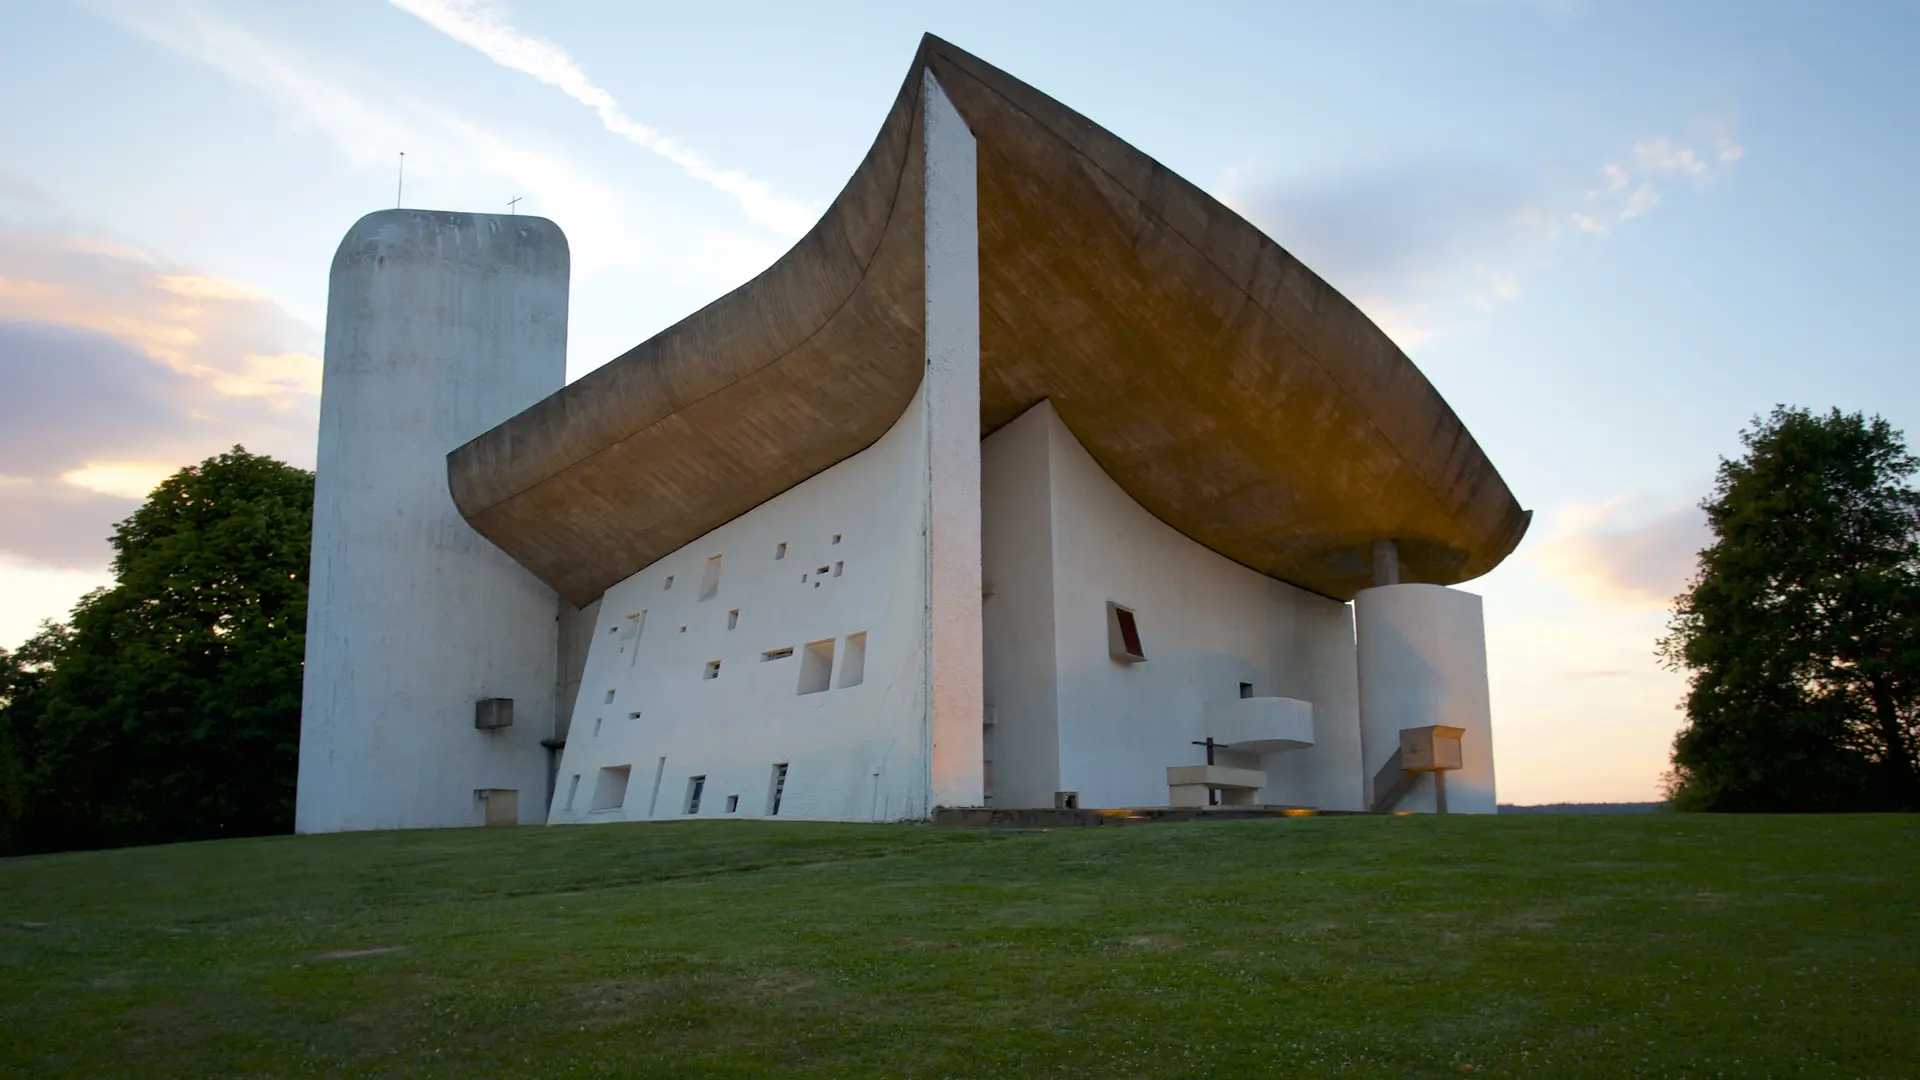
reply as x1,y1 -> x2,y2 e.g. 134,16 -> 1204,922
983,402 -> 1361,809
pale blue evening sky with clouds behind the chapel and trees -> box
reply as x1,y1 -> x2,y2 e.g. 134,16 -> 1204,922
0,0 -> 1920,803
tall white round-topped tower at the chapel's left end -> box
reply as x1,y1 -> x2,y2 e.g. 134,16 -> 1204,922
294,209 -> 568,832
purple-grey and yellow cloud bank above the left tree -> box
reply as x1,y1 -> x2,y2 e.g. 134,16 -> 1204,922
0,219 -> 321,571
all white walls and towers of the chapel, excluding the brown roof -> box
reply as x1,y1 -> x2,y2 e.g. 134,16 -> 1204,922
296,88 -> 1494,832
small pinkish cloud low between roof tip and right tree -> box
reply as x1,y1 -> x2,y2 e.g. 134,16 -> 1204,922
1540,496 -> 1713,609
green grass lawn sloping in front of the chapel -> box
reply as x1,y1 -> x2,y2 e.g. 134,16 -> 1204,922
0,815 -> 1920,1078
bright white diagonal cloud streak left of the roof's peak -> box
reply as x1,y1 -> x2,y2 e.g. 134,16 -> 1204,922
390,0 -> 820,236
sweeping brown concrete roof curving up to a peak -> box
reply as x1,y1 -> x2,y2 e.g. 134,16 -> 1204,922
447,35 -> 1530,603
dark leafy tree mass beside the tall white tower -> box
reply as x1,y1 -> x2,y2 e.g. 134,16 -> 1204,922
0,446 -> 313,849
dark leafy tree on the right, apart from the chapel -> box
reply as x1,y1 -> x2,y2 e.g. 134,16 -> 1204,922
1659,405 -> 1920,811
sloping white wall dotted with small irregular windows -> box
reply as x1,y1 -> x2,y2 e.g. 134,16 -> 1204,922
551,376 -> 929,822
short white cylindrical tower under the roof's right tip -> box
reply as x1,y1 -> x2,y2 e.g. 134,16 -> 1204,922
1354,584 -> 1498,813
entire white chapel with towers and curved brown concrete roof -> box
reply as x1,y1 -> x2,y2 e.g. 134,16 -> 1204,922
296,37 -> 1528,832
